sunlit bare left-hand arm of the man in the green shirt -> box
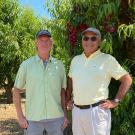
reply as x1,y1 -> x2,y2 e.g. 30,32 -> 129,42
12,87 -> 28,128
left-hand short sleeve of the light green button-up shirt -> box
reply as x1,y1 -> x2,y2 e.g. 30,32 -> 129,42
14,62 -> 26,90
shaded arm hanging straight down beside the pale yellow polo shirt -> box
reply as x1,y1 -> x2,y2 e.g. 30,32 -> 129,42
66,77 -> 73,110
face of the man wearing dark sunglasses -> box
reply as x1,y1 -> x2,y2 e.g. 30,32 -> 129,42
82,32 -> 100,53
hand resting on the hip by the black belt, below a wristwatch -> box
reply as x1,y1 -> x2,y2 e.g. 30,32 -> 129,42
99,100 -> 118,109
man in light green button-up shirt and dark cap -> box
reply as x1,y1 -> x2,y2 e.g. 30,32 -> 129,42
13,30 -> 68,135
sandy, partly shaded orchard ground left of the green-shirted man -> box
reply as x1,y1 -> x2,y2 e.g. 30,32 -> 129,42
0,104 -> 24,135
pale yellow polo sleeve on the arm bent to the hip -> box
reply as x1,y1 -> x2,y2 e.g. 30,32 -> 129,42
108,56 -> 128,80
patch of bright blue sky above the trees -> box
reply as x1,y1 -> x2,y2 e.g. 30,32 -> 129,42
20,0 -> 50,18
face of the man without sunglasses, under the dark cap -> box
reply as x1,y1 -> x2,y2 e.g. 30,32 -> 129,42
36,35 -> 52,53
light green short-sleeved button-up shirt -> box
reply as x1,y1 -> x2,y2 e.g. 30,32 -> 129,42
14,55 -> 66,121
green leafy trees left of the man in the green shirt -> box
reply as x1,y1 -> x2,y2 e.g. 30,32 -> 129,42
0,0 -> 43,103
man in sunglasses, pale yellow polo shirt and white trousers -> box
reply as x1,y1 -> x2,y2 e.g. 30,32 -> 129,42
66,28 -> 132,135
